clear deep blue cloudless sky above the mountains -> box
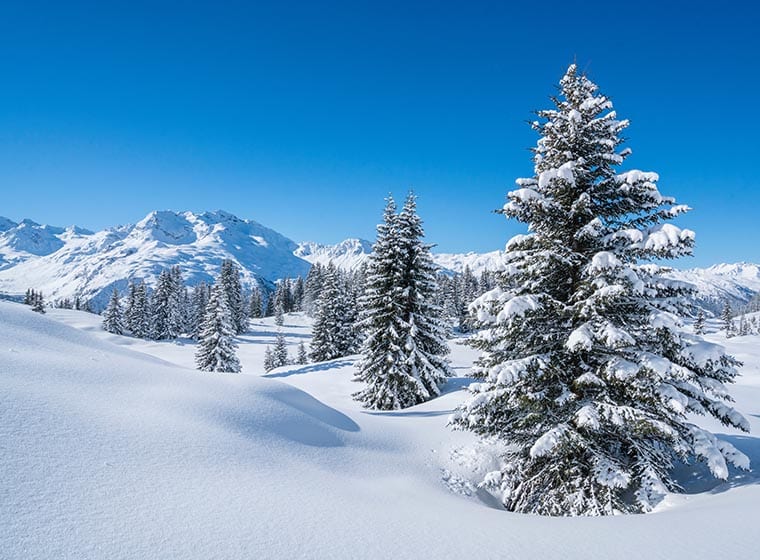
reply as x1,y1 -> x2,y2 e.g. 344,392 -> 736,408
0,0 -> 760,266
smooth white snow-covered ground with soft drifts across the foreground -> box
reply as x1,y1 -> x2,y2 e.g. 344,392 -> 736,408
0,302 -> 760,560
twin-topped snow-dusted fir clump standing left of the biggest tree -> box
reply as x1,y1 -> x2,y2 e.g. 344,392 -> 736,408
355,193 -> 451,410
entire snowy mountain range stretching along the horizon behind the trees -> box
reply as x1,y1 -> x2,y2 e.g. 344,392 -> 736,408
0,210 -> 760,312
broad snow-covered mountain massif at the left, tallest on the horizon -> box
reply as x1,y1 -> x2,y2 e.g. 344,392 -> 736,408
0,211 -> 310,307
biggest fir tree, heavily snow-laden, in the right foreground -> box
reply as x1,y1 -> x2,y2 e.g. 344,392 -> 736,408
451,65 -> 748,515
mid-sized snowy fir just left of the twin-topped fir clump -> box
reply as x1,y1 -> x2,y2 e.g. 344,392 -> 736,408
309,263 -> 357,362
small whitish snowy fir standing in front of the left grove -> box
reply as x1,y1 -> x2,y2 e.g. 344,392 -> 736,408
195,280 -> 240,373
